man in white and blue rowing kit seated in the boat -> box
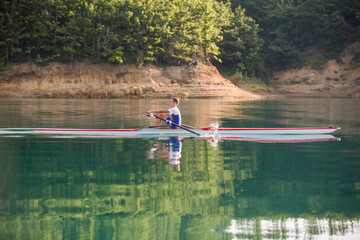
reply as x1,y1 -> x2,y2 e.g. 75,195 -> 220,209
147,97 -> 181,128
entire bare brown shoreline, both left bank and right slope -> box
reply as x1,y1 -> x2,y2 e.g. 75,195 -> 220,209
0,42 -> 360,100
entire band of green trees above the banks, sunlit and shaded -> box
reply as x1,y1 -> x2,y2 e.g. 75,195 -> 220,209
0,0 -> 360,77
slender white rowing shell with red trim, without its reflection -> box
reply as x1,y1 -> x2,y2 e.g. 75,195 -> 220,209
0,127 -> 340,137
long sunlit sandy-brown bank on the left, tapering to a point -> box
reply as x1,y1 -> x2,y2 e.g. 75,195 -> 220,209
0,62 -> 262,100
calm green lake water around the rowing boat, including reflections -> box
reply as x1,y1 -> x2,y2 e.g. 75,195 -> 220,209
0,99 -> 360,240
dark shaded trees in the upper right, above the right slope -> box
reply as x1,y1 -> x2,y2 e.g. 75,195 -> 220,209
231,0 -> 360,70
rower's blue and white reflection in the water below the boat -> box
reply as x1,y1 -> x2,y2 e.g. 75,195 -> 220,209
148,137 -> 182,171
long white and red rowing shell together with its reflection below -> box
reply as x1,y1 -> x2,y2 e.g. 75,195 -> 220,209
0,128 -> 340,143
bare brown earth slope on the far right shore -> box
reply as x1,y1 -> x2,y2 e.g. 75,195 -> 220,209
273,42 -> 360,98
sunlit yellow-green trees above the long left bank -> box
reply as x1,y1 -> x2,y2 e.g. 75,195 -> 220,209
0,0 -> 231,65
